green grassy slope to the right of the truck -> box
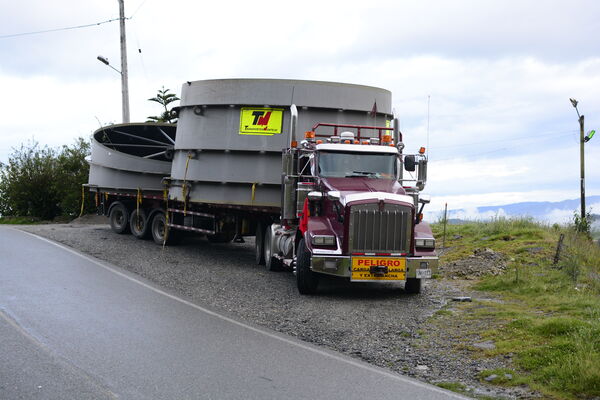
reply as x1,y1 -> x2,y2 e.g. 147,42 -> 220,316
433,218 -> 600,399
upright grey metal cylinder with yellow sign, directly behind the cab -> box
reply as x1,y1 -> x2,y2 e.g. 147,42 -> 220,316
170,79 -> 392,210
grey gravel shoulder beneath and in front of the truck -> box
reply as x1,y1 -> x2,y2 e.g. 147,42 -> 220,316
18,222 -> 533,398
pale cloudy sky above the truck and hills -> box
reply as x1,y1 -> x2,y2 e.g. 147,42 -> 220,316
0,0 -> 600,220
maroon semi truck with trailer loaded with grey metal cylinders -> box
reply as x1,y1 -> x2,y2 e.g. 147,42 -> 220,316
88,80 -> 438,294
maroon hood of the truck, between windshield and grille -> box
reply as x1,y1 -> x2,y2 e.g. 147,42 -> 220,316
321,177 -> 413,205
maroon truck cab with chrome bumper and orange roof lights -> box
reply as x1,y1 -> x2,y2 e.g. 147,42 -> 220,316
273,114 -> 438,294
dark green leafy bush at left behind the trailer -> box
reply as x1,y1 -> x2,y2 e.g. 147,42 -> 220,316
0,138 -> 90,220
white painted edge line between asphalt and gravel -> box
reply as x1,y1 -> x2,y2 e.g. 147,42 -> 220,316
10,228 -> 470,400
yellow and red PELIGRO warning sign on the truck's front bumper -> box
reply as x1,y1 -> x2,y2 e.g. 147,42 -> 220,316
350,257 -> 406,282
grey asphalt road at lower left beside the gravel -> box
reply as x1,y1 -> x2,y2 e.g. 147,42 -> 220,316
0,227 -> 462,400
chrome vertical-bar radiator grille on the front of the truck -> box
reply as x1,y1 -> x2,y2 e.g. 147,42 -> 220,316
349,203 -> 412,253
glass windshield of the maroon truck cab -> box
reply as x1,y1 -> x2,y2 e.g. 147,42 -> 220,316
319,151 -> 397,179
